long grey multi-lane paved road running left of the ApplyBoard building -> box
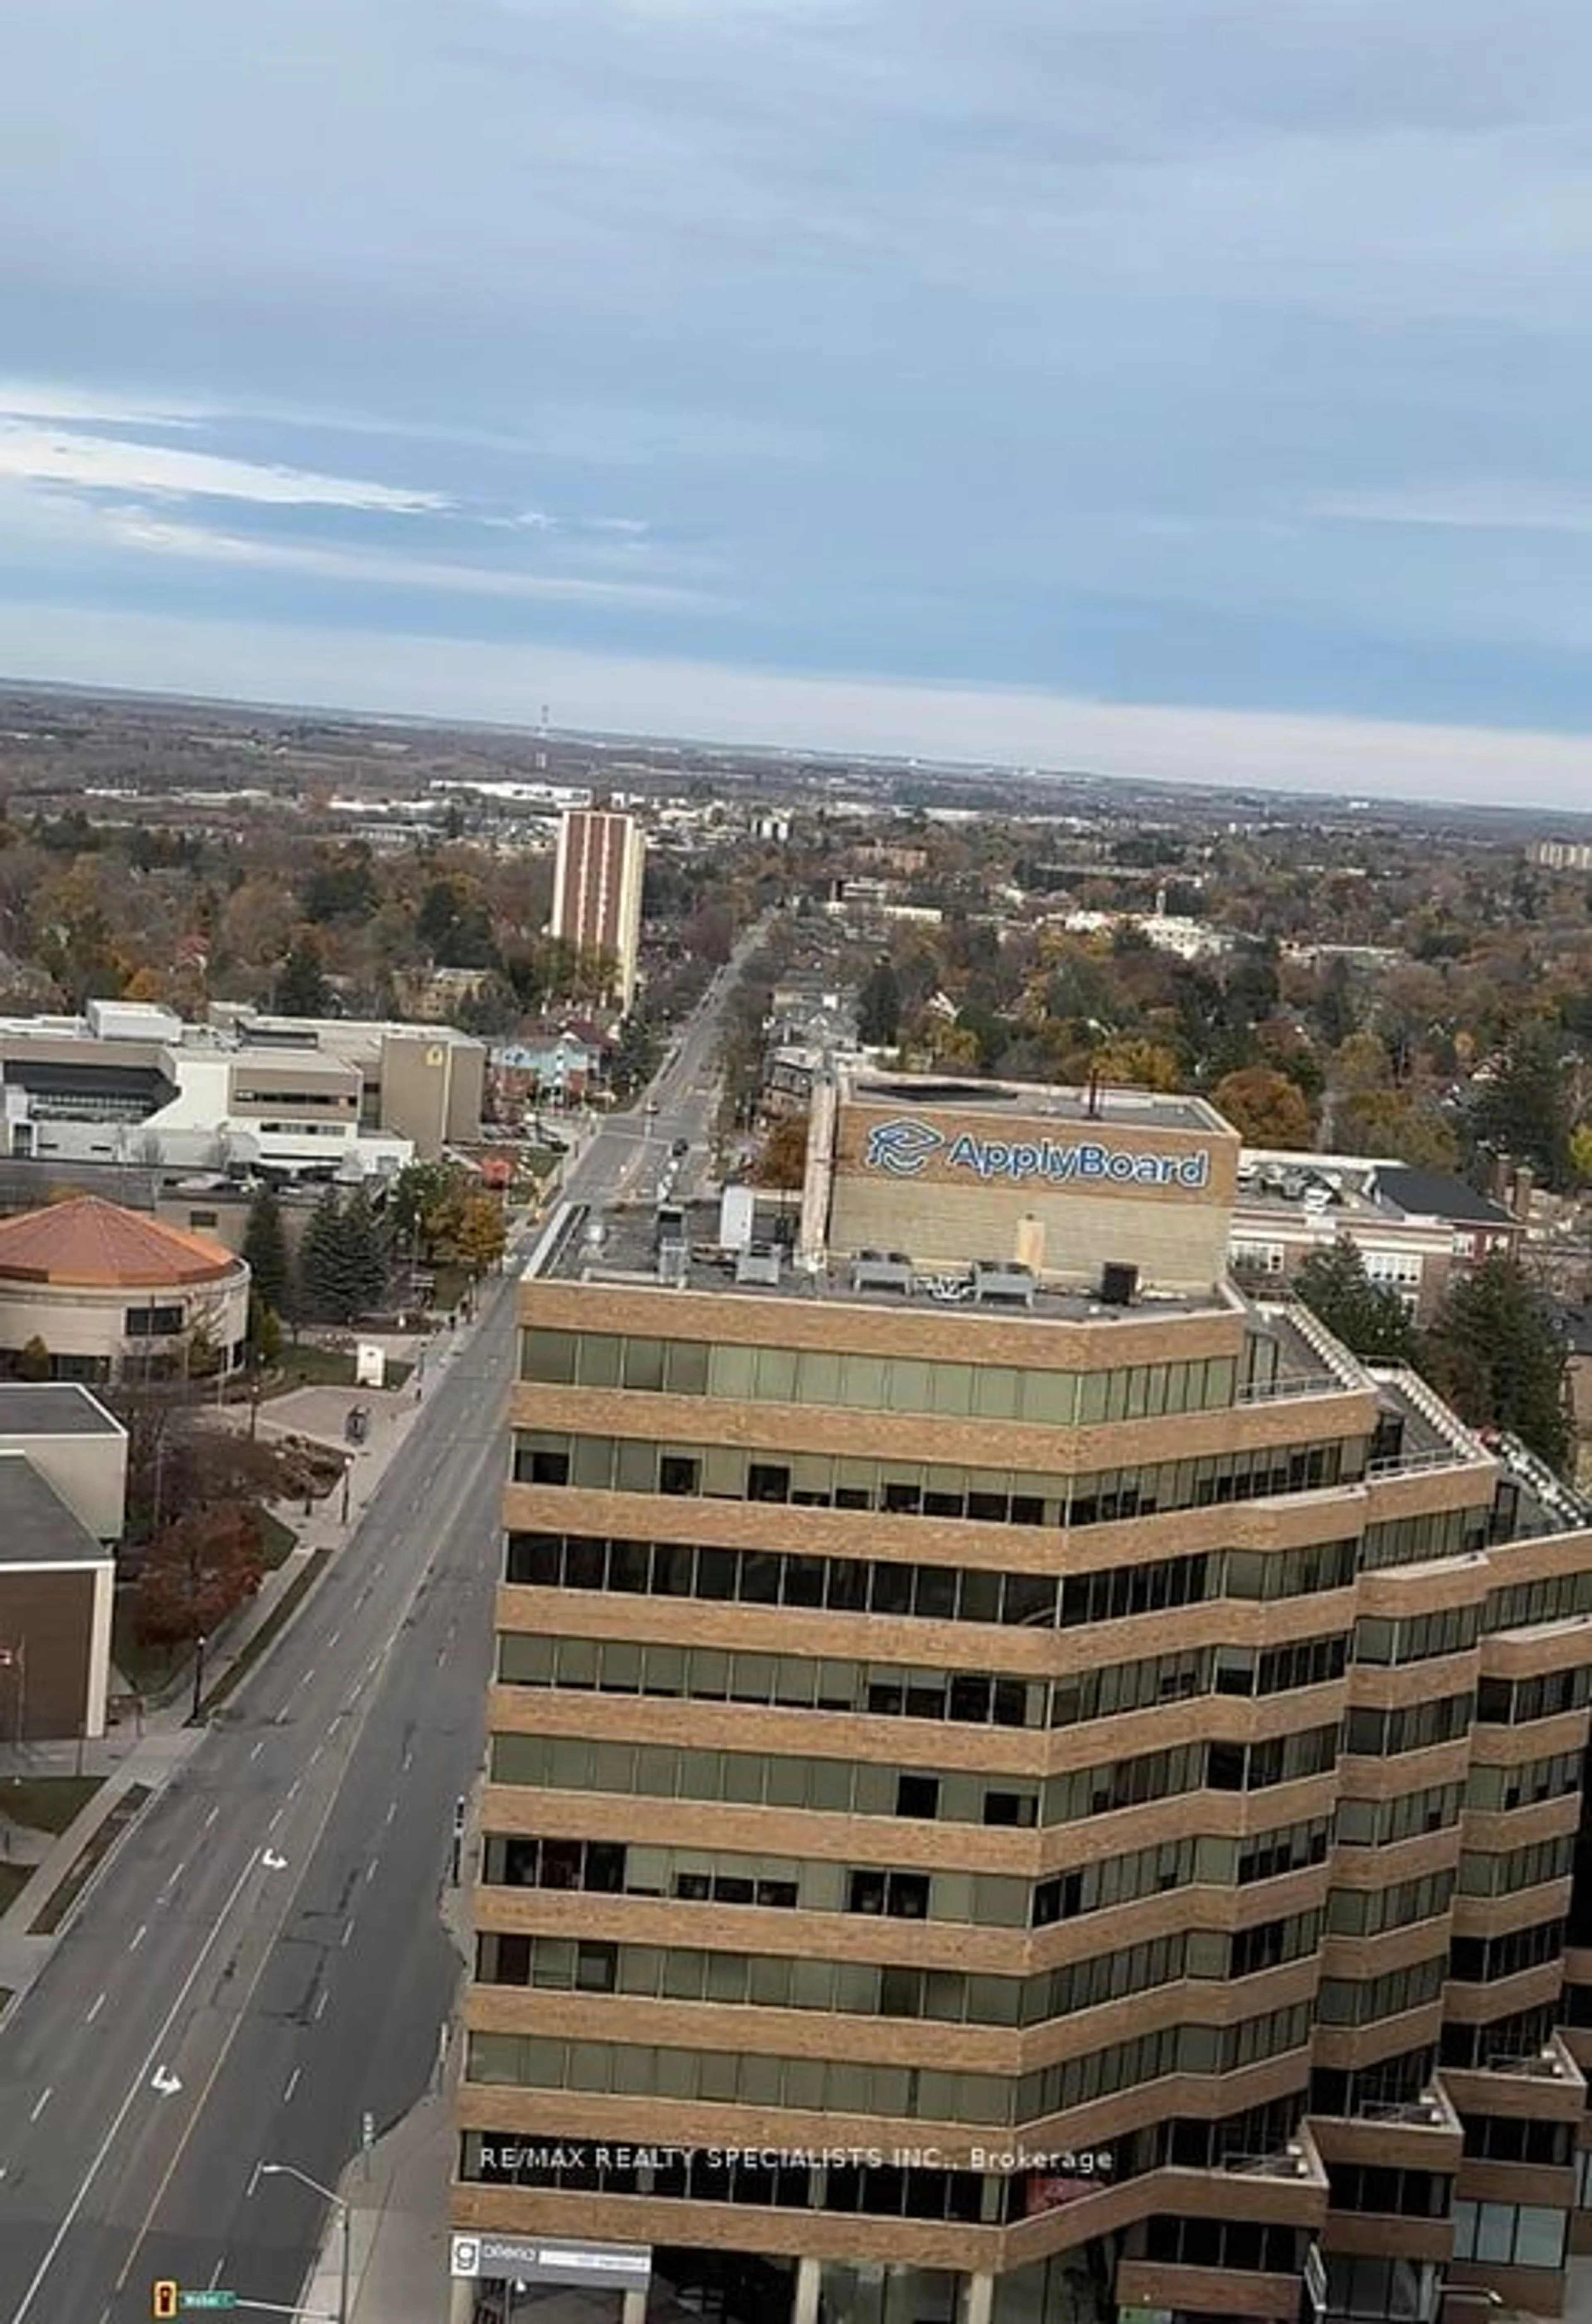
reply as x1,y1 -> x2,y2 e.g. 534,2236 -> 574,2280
0,937 -> 753,2324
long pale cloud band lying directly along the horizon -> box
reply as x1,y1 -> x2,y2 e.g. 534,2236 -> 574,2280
0,606 -> 1592,807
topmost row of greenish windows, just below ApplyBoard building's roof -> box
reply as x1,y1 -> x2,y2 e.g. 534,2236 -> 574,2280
521,1329 -> 1239,1429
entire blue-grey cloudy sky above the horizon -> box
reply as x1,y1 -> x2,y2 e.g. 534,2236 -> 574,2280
0,0 -> 1592,809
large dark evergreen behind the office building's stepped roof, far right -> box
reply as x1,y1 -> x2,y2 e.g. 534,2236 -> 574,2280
1420,1253 -> 1573,1469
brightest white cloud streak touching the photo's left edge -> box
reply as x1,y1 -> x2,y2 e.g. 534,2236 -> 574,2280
0,418 -> 449,516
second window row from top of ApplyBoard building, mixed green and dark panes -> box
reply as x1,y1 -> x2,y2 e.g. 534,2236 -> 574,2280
514,1429 -> 1364,1527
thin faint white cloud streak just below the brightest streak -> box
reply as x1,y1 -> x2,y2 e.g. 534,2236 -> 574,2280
104,509 -> 706,611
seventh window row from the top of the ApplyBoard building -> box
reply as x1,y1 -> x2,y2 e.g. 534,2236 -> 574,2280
476,1915 -> 1320,2026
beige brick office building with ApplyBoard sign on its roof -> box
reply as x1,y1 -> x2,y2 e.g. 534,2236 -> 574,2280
453,1078 -> 1592,2324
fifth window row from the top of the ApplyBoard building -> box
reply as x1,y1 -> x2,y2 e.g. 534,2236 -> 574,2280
490,1722 -> 1339,1827
